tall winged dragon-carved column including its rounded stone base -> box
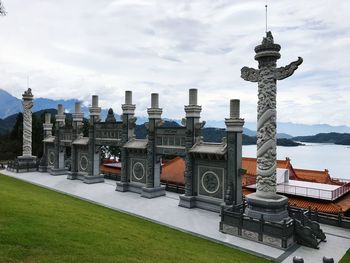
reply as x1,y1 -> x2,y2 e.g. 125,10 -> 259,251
241,32 -> 303,221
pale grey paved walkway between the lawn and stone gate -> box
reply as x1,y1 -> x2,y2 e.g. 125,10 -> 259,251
0,170 -> 350,263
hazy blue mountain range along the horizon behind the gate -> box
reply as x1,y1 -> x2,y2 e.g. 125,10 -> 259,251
0,89 -> 350,139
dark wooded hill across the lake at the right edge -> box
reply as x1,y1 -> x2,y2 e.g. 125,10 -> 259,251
293,132 -> 350,145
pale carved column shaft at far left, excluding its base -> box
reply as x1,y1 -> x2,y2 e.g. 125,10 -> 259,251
22,88 -> 34,158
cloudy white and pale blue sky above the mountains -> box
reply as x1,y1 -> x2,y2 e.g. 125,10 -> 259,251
0,0 -> 350,125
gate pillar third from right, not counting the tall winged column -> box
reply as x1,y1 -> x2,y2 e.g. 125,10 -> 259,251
141,93 -> 165,198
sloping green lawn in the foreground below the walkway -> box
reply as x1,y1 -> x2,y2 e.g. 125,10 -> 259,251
0,175 -> 268,263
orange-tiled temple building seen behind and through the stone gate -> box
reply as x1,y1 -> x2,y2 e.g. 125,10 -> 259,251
101,157 -> 350,215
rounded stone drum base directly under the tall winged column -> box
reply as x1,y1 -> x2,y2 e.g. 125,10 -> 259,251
245,193 -> 289,222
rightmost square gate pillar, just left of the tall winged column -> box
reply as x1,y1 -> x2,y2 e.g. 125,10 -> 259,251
225,100 -> 244,205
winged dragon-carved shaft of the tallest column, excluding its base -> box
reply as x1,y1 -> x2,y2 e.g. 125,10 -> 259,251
241,32 -> 303,198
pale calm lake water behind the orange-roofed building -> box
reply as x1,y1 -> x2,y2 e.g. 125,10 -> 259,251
243,143 -> 350,179
